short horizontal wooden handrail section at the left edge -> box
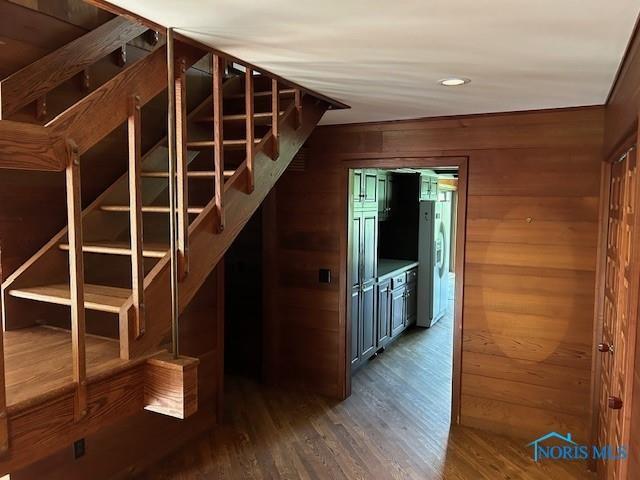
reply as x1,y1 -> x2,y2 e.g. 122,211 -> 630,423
0,120 -> 67,172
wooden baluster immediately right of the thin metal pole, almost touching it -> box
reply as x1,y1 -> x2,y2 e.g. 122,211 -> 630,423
175,58 -> 189,279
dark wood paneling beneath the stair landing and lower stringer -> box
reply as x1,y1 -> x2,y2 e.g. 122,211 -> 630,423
11,263 -> 224,480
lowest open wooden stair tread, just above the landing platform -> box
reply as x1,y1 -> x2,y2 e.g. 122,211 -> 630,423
9,283 -> 131,313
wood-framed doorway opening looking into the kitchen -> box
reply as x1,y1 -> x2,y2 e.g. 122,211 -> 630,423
345,158 -> 467,426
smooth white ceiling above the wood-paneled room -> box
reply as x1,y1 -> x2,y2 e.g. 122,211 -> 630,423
107,0 -> 640,123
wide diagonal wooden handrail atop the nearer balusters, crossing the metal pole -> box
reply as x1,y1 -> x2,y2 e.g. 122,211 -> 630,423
46,44 -> 203,155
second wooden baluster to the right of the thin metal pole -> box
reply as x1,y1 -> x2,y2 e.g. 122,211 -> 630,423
211,53 -> 224,232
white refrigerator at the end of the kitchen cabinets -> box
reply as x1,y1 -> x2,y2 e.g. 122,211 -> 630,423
416,200 -> 450,327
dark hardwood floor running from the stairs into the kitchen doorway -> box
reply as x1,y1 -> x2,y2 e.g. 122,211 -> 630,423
140,310 -> 595,480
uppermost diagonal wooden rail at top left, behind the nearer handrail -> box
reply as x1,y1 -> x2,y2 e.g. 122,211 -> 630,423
0,17 -> 147,119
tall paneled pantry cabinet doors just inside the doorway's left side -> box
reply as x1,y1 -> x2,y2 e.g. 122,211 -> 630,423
350,204 -> 378,367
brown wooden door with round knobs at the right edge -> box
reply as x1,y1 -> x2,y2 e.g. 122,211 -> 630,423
597,150 -> 639,480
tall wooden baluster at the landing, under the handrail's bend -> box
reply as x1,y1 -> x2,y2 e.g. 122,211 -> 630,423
66,140 -> 87,420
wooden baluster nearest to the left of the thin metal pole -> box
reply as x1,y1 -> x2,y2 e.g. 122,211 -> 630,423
127,95 -> 145,338
